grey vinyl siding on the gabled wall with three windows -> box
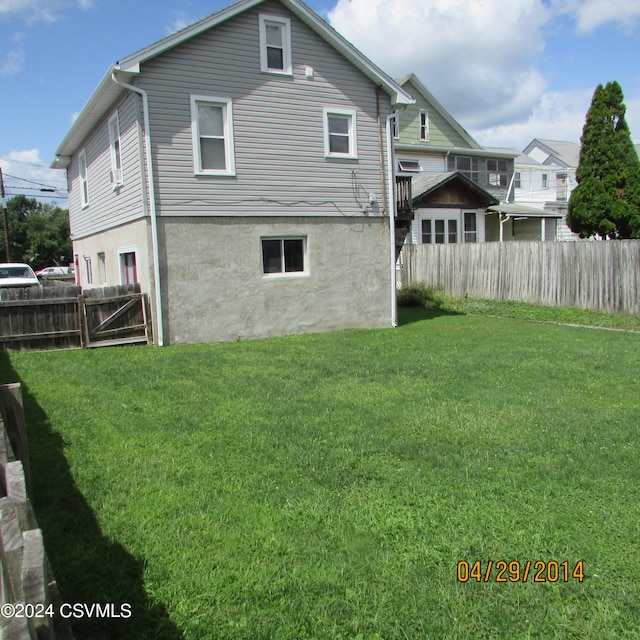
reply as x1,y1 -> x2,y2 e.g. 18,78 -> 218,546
138,2 -> 390,216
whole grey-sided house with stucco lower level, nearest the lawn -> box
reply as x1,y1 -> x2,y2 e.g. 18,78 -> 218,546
52,0 -> 412,344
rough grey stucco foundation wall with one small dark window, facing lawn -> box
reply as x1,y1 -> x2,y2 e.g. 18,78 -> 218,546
159,217 -> 391,344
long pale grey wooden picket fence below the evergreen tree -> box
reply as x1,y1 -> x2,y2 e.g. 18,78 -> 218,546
400,240 -> 640,313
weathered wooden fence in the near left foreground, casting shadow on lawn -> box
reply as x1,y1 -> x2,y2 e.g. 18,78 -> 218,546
0,384 -> 72,640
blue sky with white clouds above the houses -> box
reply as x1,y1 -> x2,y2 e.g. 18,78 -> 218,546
0,0 -> 640,206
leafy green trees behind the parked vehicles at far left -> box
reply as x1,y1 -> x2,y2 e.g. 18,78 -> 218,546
0,195 -> 72,270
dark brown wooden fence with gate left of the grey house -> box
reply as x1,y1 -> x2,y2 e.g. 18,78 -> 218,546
0,284 -> 151,351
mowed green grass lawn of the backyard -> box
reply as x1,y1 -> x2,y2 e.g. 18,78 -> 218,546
3,310 -> 640,640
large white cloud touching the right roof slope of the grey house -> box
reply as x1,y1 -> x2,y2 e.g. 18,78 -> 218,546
328,0 -> 551,128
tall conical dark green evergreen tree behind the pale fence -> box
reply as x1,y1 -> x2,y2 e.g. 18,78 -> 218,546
567,81 -> 640,239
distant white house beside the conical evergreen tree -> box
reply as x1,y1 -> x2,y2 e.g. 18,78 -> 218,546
514,138 -> 580,240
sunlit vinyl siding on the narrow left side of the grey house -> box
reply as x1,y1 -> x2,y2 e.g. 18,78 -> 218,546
68,94 -> 146,239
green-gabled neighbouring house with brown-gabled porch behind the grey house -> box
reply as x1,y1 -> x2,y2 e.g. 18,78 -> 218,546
394,74 -> 518,244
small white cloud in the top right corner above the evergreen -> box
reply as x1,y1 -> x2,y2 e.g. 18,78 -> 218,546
553,0 -> 640,33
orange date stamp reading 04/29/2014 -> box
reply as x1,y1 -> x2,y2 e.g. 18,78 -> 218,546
456,560 -> 585,583
